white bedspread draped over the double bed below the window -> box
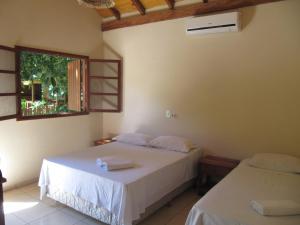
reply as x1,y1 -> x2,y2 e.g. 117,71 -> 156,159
39,142 -> 200,225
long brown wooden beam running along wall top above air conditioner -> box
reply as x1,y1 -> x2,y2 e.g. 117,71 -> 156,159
102,0 -> 284,31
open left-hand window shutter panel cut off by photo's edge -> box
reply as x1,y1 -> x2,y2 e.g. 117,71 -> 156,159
0,45 -> 17,120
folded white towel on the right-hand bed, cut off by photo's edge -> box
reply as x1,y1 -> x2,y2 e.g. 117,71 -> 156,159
250,200 -> 300,216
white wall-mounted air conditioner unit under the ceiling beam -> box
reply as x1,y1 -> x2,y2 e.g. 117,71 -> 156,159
186,12 -> 241,35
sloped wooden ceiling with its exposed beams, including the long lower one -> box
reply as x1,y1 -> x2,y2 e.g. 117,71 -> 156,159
97,0 -> 284,31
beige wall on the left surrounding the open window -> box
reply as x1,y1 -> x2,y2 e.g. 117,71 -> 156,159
0,0 -> 102,188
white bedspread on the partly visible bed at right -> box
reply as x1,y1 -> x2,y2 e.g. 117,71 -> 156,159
186,160 -> 300,225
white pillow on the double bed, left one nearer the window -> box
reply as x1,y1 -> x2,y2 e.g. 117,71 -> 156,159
114,133 -> 153,146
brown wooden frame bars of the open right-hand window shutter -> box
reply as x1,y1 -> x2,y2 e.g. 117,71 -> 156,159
88,59 -> 123,113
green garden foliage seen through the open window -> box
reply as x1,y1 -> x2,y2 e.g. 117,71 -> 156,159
20,51 -> 74,113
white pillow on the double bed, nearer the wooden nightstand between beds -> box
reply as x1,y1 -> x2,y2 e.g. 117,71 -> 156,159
150,136 -> 194,152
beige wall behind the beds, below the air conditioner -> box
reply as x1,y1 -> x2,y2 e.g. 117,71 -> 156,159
103,0 -> 300,158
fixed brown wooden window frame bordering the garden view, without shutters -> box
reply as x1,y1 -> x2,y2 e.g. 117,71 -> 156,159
13,46 -> 89,121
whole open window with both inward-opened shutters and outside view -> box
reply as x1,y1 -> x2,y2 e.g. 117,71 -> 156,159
0,45 -> 122,120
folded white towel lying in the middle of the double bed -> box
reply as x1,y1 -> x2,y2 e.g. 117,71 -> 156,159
96,157 -> 134,171
